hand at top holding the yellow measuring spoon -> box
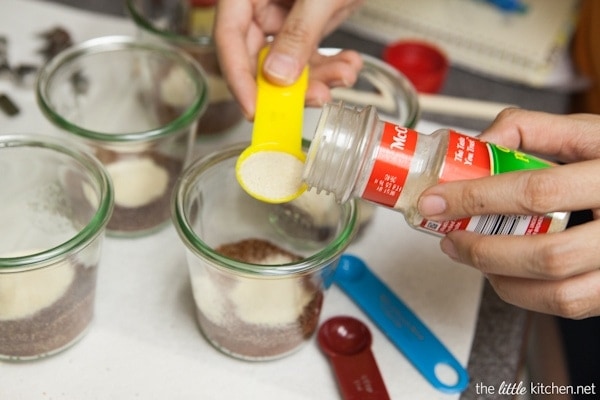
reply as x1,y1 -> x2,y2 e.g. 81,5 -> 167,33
214,0 -> 363,120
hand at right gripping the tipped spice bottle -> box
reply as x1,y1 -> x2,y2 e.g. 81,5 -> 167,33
419,109 -> 600,319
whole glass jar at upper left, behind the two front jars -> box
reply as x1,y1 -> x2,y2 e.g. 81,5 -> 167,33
37,36 -> 208,237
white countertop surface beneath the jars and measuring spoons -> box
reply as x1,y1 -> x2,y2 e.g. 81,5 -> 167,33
0,0 -> 483,400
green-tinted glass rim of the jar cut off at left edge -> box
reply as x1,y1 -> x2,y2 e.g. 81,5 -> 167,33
0,134 -> 114,273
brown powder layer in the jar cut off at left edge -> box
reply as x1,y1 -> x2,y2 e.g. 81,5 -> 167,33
0,265 -> 97,359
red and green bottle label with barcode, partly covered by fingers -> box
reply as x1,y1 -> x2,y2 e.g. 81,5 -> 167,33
421,131 -> 552,235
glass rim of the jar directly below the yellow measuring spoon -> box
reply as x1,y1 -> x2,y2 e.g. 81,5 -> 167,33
171,140 -> 358,277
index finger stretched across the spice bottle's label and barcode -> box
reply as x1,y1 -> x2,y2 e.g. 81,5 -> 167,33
418,160 -> 600,221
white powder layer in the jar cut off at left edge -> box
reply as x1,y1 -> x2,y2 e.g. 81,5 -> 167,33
0,255 -> 75,321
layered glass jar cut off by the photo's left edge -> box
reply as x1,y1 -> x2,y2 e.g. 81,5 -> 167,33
0,135 -> 113,361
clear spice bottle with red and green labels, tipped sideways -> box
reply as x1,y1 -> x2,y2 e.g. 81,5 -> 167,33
303,102 -> 569,235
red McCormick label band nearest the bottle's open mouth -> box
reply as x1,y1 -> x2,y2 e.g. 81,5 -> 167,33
362,122 -> 418,207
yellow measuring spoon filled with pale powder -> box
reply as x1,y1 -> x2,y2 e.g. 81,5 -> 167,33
235,47 -> 308,203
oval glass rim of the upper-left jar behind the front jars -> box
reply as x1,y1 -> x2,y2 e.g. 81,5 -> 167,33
36,35 -> 208,143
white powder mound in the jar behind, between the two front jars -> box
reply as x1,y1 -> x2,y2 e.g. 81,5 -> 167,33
106,157 -> 169,208
